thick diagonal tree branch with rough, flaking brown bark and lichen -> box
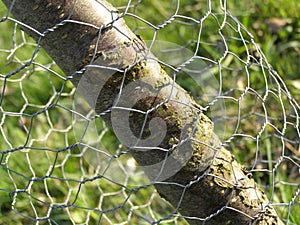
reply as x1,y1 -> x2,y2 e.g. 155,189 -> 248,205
3,0 -> 283,225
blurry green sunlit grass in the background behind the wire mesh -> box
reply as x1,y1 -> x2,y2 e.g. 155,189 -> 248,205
0,0 -> 300,225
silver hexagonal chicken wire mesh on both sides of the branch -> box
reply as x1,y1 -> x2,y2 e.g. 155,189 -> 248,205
0,0 -> 300,224
